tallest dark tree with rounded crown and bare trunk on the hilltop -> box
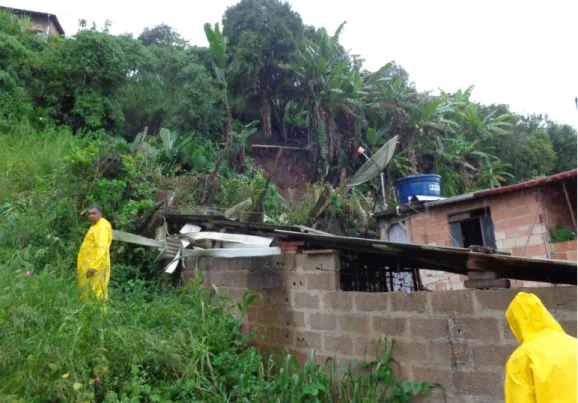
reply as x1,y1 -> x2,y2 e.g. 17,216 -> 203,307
223,0 -> 303,138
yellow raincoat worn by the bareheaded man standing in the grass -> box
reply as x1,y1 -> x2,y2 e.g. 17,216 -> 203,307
77,218 -> 112,300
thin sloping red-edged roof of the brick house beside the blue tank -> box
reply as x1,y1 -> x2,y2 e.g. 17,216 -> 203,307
373,169 -> 578,218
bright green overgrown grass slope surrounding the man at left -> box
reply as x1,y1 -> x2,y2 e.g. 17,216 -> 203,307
0,125 -> 440,403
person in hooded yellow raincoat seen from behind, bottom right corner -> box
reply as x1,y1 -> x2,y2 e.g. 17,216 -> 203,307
504,292 -> 577,403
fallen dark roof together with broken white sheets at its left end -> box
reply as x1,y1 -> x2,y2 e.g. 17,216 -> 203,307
113,213 -> 577,284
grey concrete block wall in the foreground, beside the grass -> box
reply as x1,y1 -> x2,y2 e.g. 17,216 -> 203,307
184,253 -> 576,403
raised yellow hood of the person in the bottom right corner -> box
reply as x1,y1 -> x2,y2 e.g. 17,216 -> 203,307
506,292 -> 564,344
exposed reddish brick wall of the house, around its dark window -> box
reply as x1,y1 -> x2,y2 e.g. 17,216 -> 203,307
382,184 -> 577,291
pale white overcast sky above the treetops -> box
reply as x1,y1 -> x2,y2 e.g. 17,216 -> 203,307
5,0 -> 578,128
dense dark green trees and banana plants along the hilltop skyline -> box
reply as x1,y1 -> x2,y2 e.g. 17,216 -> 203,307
0,0 -> 576,211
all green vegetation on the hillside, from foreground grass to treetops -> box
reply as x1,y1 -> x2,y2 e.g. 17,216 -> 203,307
0,0 -> 576,402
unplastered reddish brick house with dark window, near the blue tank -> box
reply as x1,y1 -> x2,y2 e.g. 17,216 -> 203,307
374,170 -> 577,290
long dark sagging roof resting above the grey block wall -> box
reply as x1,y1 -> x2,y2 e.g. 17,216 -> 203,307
164,213 -> 577,285
